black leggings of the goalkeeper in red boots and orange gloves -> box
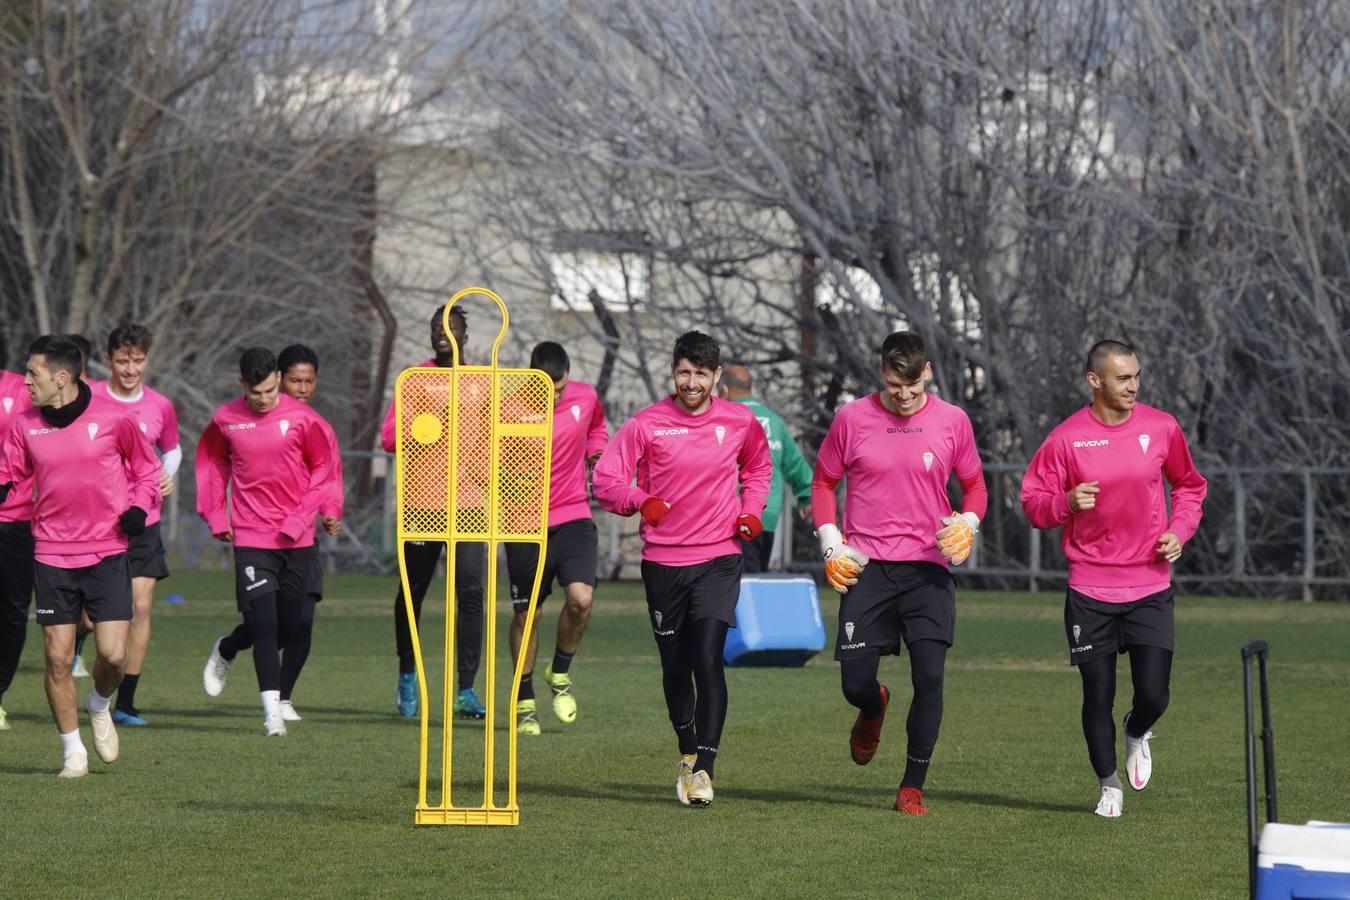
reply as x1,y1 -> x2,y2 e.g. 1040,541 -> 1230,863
840,641 -> 948,788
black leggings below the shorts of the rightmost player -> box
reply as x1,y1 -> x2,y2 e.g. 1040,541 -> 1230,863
1079,644 -> 1172,779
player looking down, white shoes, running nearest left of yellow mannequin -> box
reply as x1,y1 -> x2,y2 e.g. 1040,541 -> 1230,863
196,347 -> 333,737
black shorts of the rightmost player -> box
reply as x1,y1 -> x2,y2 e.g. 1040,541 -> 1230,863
1064,587 -> 1176,665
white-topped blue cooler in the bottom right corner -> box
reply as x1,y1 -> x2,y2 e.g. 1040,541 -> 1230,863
1257,822 -> 1350,900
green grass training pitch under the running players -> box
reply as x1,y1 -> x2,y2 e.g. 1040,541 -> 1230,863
0,573 -> 1350,897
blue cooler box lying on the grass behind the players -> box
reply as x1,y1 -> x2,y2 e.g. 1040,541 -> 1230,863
724,575 -> 825,665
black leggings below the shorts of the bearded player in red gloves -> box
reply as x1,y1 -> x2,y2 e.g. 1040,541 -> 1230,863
656,619 -> 729,777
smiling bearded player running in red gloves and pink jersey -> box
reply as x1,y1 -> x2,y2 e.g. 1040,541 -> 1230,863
593,331 -> 772,807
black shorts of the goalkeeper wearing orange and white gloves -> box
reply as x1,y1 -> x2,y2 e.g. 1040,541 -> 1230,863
834,560 -> 956,660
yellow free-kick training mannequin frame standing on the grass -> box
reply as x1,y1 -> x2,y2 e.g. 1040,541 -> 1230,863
394,287 -> 554,824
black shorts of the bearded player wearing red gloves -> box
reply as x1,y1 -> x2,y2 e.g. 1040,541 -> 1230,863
643,553 -> 741,644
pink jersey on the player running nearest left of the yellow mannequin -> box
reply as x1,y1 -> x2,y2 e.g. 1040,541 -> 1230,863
196,394 -> 333,551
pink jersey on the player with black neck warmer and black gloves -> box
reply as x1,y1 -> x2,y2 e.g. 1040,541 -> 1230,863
0,397 -> 159,568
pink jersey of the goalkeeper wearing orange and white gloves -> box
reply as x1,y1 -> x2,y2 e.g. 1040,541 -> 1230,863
811,393 -> 988,567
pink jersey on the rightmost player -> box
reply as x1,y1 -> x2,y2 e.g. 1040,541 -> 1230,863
1022,403 -> 1206,602
